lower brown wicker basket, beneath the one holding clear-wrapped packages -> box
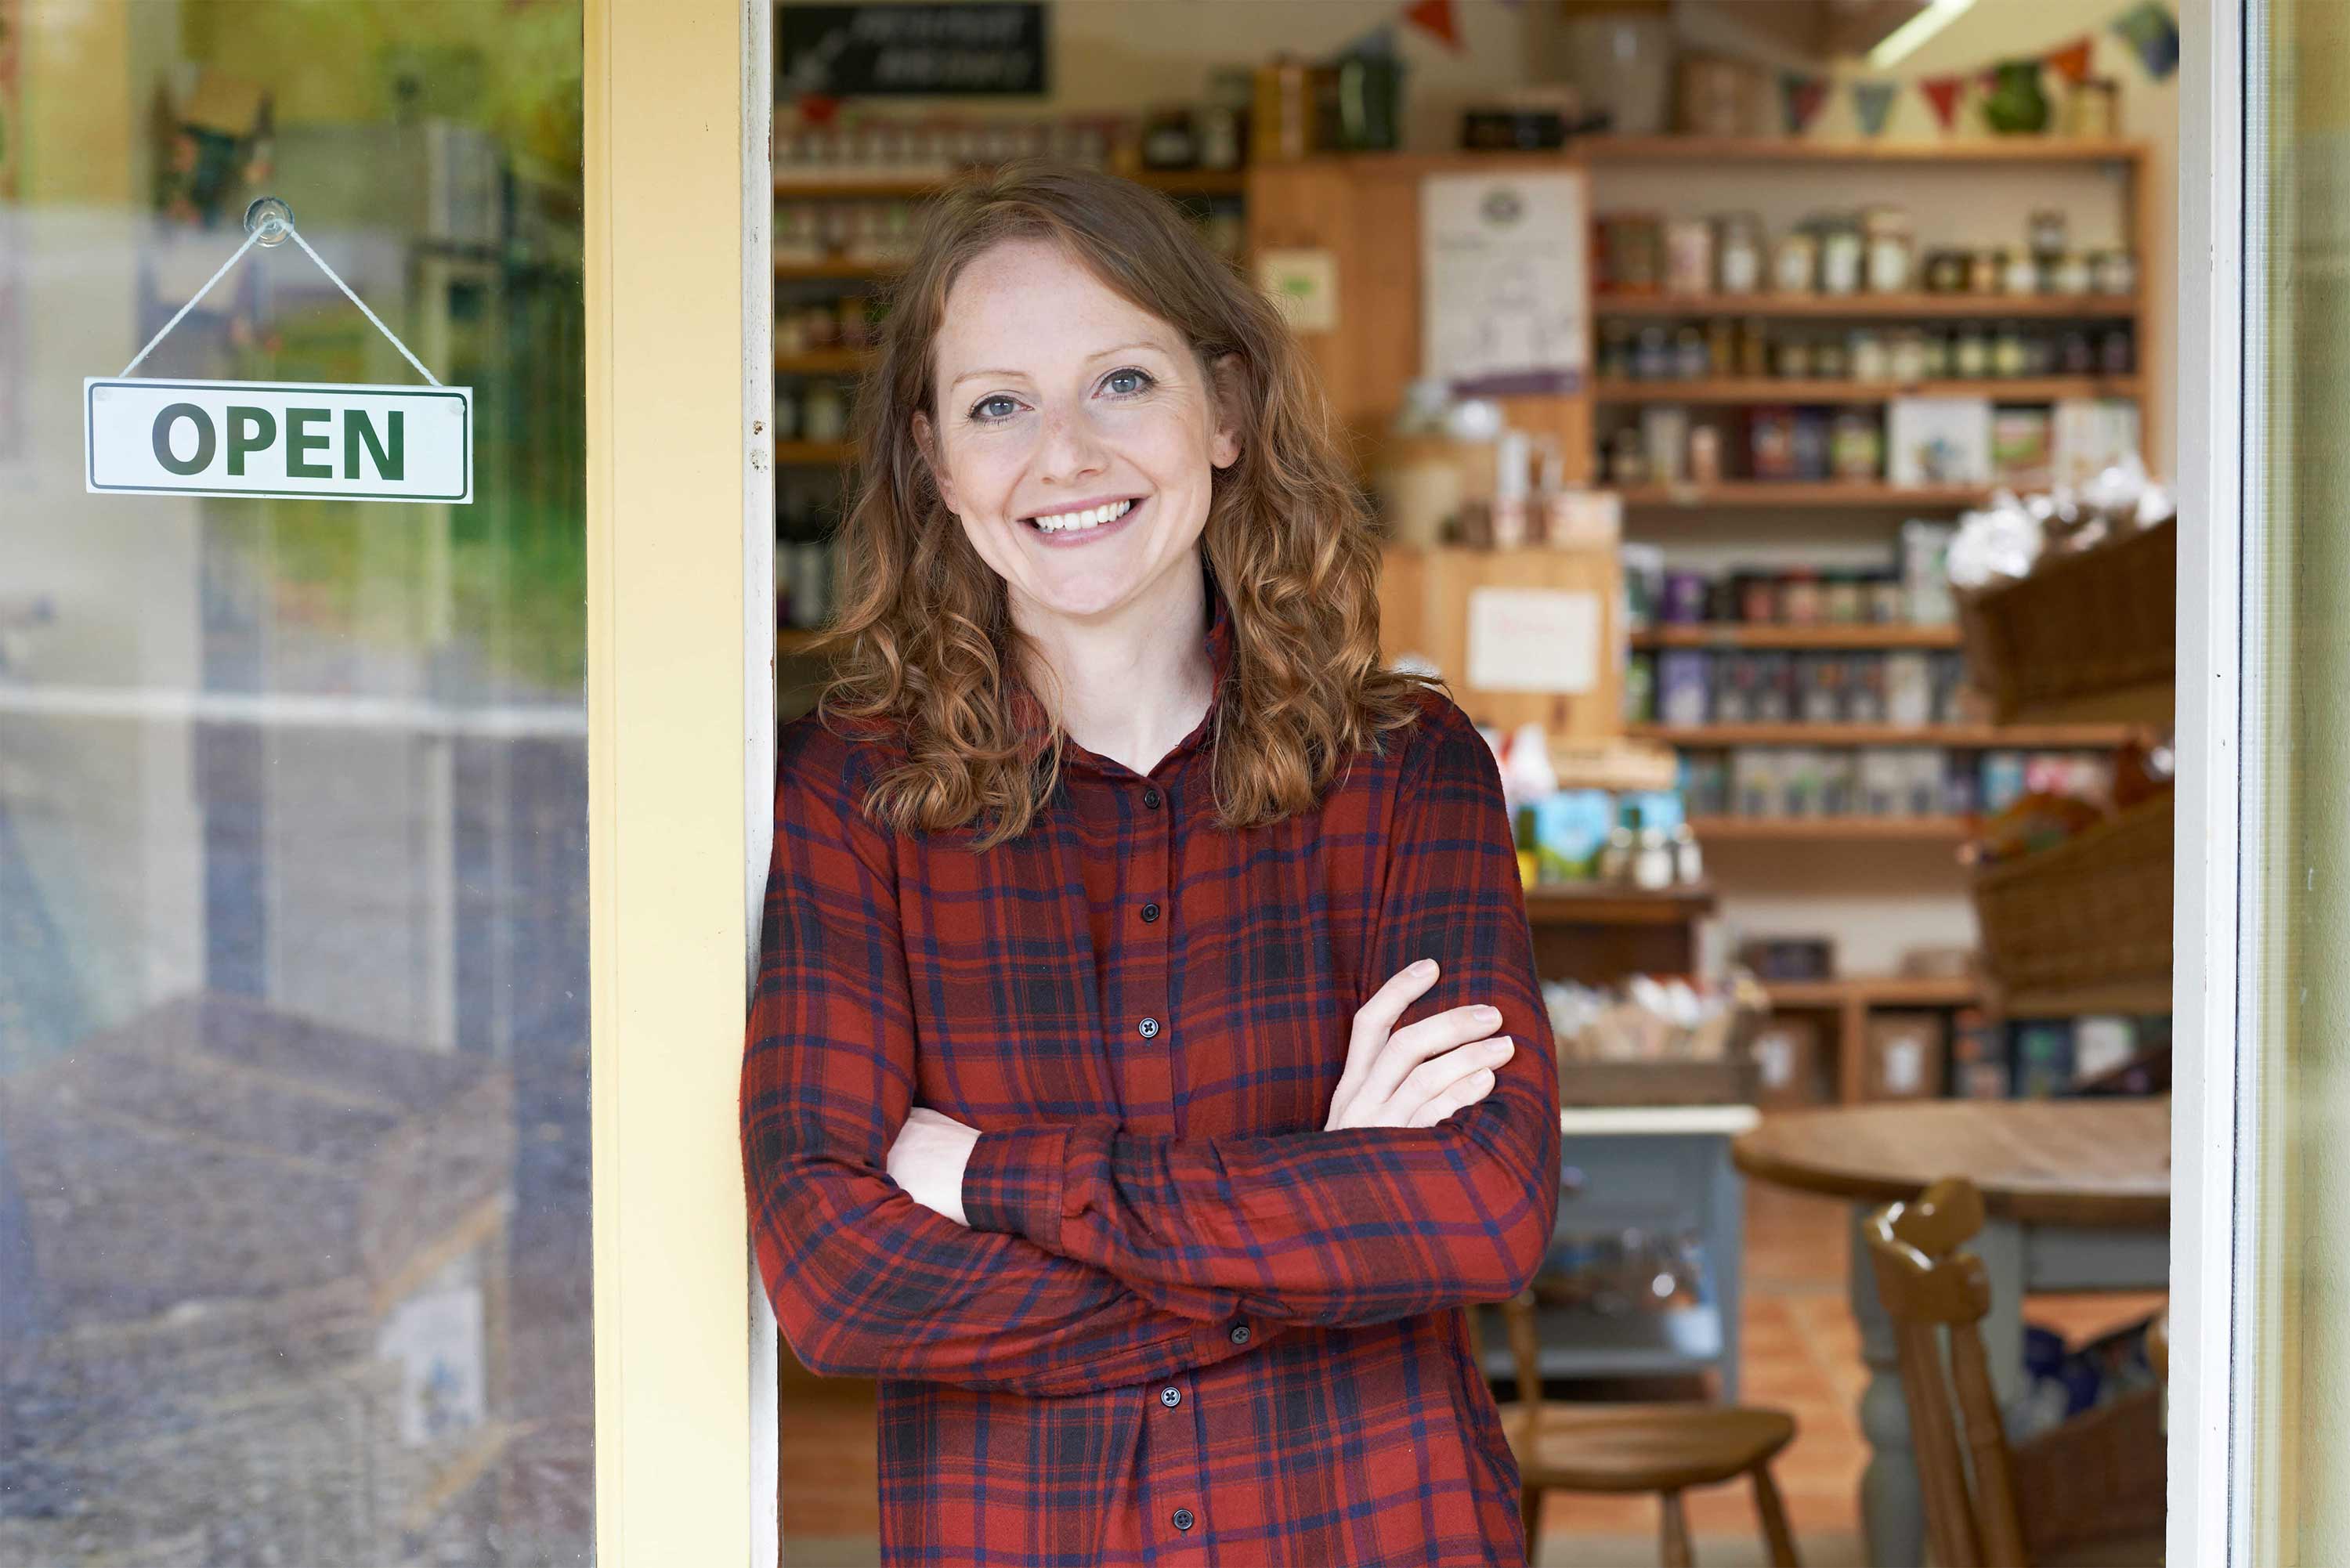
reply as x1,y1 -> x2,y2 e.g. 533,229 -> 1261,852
1974,793 -> 2171,992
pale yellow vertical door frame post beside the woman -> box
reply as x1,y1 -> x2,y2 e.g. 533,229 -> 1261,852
583,0 -> 776,1568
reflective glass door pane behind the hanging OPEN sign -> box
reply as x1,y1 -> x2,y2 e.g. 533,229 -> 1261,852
0,0 -> 597,1568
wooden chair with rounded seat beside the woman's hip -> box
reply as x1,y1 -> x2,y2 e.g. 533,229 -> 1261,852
1469,1291 -> 1798,1568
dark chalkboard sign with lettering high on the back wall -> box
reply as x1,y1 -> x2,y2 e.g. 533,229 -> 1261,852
776,2 -> 1050,99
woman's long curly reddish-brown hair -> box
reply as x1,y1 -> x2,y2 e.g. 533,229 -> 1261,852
818,157 -> 1431,849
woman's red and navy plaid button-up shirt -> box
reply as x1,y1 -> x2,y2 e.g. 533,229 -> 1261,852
743,557 -> 1558,1568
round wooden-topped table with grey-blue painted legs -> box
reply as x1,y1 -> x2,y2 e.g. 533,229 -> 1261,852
1732,1096 -> 2171,1568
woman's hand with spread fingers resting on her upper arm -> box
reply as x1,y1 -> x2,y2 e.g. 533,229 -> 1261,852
1323,959 -> 1516,1131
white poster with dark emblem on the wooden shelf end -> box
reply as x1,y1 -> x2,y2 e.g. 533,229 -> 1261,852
1419,172 -> 1591,397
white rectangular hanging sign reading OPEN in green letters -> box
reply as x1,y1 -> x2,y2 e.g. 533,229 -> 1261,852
82,378 -> 472,503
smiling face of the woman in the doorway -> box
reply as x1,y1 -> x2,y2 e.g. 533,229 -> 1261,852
914,240 -> 1241,618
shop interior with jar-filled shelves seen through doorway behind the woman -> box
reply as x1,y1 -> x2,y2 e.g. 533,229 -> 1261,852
773,0 -> 2178,1566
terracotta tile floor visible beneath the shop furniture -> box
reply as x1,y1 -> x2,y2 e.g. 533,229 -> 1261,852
783,1185 -> 2162,1568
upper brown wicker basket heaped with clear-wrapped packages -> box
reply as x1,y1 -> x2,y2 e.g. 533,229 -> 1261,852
1958,522 -> 2178,724
